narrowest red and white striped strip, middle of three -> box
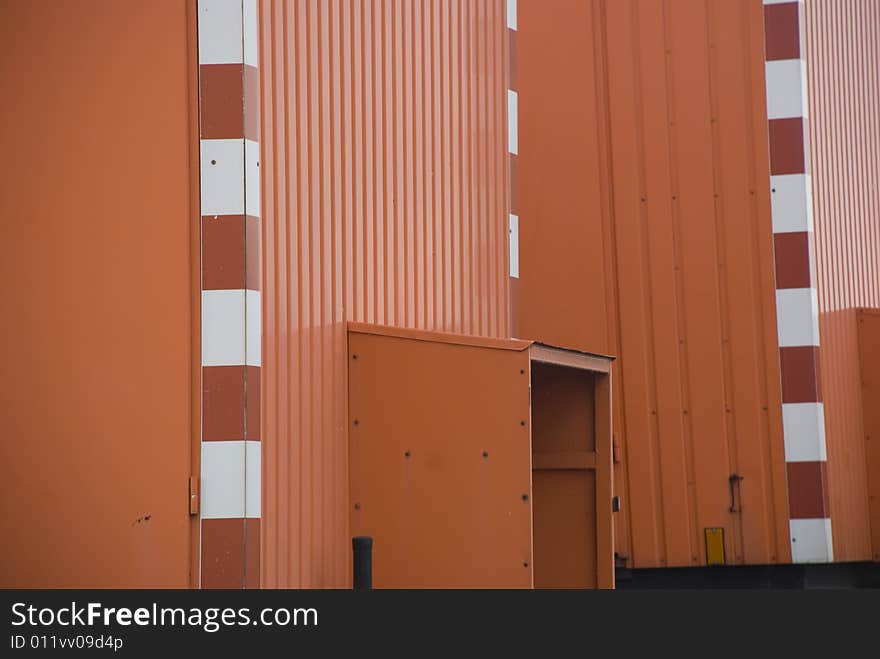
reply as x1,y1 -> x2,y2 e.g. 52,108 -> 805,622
507,0 -> 519,336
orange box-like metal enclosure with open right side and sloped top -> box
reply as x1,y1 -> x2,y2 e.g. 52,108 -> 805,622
347,323 -> 614,588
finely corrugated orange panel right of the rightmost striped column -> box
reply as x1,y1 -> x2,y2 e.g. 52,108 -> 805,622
806,0 -> 880,561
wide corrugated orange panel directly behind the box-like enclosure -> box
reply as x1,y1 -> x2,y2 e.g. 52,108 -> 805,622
260,0 -> 508,587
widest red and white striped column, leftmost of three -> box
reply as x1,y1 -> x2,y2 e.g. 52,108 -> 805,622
198,0 -> 262,588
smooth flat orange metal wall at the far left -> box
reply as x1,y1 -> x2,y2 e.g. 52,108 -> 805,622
0,0 -> 198,587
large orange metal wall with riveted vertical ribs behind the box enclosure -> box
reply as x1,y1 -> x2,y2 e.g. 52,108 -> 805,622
517,0 -> 790,567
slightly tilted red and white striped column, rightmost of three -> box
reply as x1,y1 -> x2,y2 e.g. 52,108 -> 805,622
764,0 -> 834,563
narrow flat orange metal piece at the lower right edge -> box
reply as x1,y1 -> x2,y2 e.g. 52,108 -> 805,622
858,309 -> 880,561
